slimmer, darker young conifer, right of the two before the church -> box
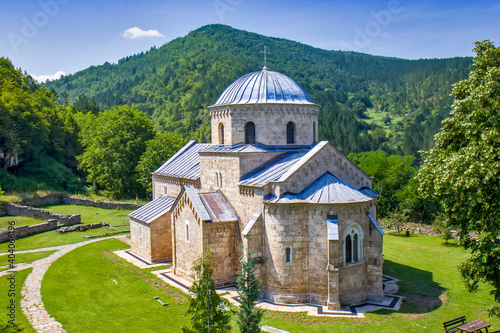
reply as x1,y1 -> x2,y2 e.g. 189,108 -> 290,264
236,253 -> 262,333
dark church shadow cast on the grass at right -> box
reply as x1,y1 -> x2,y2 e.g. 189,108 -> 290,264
384,260 -> 446,314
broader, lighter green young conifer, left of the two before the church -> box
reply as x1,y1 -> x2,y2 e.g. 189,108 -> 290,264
181,251 -> 231,333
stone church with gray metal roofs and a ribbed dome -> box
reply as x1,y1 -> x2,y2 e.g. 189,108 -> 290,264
129,67 -> 384,310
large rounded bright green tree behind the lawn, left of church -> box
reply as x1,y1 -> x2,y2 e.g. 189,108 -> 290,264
77,105 -> 155,197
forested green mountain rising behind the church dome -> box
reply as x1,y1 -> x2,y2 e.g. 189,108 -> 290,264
46,25 -> 472,155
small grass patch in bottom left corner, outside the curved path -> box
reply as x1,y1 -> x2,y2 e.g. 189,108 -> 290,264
0,268 -> 35,333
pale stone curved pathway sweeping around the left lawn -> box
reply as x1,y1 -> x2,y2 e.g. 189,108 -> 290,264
0,236 -> 128,333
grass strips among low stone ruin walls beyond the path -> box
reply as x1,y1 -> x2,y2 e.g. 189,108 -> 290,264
0,205 -> 132,253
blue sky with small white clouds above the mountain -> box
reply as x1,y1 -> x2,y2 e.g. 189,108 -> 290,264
0,0 -> 500,79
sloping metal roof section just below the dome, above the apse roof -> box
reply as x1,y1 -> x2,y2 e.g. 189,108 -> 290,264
238,152 -> 306,187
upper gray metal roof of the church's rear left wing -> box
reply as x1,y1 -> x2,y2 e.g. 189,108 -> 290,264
153,140 -> 211,180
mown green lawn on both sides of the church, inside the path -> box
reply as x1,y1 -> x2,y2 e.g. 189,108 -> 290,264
42,235 -> 500,333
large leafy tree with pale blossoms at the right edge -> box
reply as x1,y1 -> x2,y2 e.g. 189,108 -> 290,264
418,41 -> 500,316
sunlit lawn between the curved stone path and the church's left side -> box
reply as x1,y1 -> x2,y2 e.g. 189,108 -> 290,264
42,239 -> 188,333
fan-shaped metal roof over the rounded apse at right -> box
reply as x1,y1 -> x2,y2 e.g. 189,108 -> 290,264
264,172 -> 372,204
